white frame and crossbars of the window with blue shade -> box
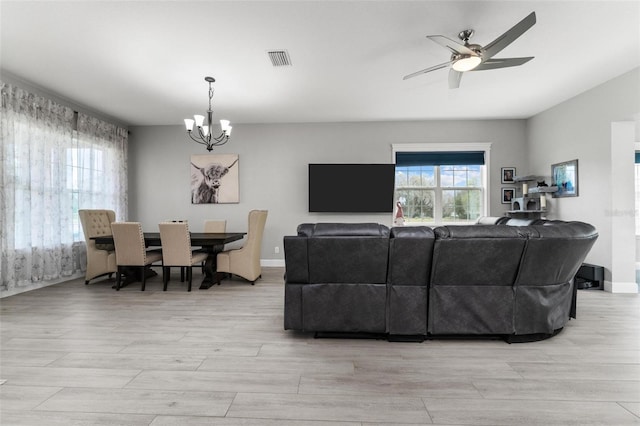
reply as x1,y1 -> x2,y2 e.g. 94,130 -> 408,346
391,142 -> 491,226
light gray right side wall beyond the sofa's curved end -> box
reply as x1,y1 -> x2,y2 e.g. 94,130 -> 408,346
527,68 -> 640,291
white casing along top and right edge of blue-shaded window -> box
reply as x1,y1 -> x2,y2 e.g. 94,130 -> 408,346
391,142 -> 491,221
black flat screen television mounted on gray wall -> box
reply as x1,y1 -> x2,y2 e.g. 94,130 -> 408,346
309,164 -> 395,213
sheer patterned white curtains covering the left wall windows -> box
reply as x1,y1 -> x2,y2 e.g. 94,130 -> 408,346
0,82 -> 127,295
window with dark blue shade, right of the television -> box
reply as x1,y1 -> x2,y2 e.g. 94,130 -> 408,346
394,144 -> 488,225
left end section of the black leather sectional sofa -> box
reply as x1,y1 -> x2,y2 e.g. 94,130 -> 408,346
284,223 -> 389,333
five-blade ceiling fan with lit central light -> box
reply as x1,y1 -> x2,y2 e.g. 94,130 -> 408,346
403,12 -> 536,89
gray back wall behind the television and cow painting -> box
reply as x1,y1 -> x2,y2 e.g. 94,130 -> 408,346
129,117 -> 527,264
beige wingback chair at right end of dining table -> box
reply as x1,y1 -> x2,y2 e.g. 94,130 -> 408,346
217,210 -> 268,285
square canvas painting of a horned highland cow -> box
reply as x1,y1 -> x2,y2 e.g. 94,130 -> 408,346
191,154 -> 240,204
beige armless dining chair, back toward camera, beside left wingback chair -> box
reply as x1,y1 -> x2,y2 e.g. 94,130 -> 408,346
111,222 -> 162,291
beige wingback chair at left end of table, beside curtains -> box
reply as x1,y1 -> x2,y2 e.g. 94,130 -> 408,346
78,209 -> 117,284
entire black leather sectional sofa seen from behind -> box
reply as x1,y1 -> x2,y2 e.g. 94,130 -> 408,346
284,218 -> 598,341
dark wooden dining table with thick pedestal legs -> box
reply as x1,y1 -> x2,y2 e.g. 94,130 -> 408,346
91,232 -> 247,290
